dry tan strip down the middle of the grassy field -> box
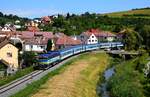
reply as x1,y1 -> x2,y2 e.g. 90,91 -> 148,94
32,61 -> 88,97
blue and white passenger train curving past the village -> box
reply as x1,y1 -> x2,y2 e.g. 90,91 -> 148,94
34,42 -> 123,70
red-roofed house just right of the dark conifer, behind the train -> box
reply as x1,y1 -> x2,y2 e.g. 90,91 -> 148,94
54,33 -> 82,49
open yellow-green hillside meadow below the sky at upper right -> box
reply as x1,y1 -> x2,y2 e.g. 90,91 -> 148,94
105,8 -> 150,18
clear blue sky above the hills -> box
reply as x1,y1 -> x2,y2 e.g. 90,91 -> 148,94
0,0 -> 150,18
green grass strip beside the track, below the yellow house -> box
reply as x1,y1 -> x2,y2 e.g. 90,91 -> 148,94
0,67 -> 33,86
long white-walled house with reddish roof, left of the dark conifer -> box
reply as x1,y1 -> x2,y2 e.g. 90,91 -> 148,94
20,32 -> 54,52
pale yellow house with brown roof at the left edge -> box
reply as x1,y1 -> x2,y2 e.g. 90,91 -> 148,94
0,37 -> 19,74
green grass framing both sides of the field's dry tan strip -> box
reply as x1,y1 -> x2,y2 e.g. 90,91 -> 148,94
11,53 -> 108,97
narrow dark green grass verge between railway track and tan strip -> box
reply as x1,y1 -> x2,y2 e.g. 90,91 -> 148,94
11,54 -> 89,97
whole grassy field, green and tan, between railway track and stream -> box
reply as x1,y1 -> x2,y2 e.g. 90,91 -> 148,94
12,52 -> 109,97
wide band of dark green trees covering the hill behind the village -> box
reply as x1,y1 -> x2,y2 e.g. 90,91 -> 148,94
40,12 -> 150,35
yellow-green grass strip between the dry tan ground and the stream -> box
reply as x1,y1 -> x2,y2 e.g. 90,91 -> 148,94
76,53 -> 109,97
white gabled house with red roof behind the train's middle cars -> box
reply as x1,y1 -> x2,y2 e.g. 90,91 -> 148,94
78,29 -> 116,44
